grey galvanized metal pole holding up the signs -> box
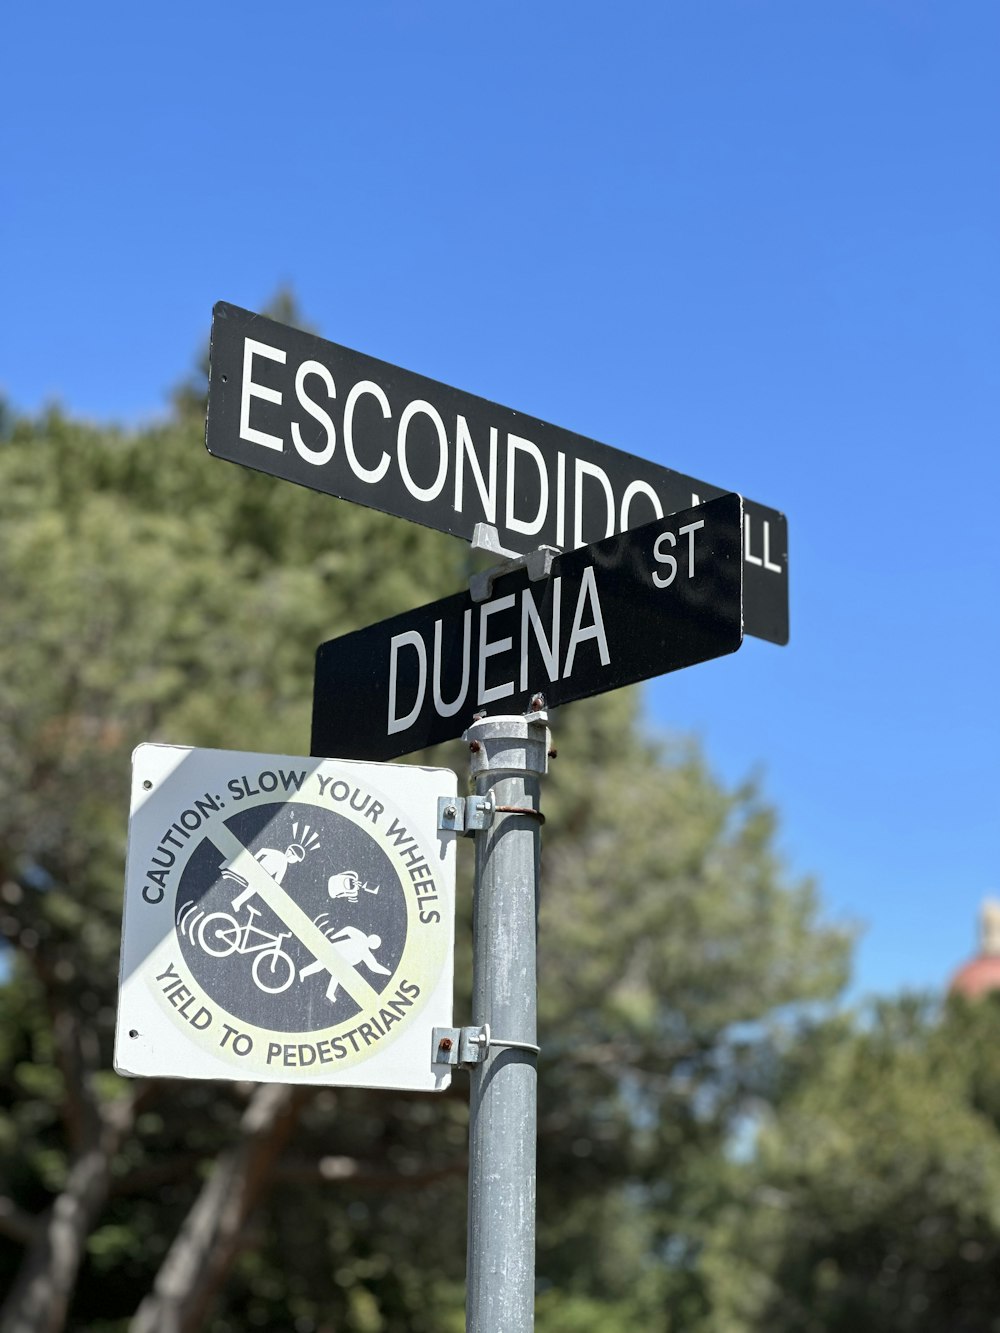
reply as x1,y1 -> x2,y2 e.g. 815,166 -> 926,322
465,712 -> 549,1333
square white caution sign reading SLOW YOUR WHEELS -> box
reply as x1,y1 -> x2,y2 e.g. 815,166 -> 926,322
115,745 -> 456,1090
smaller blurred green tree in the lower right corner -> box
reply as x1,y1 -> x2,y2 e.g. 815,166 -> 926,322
704,996 -> 1000,1333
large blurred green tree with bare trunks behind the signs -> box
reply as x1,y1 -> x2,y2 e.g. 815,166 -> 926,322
0,296 -> 864,1333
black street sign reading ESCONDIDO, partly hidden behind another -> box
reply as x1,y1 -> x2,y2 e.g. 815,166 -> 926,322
205,301 -> 788,644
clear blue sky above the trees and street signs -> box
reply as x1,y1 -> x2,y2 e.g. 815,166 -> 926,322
0,0 -> 1000,993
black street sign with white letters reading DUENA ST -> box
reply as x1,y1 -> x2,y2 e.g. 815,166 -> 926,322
312,495 -> 743,760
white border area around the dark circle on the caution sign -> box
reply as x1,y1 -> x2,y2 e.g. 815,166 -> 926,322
115,744 -> 457,1092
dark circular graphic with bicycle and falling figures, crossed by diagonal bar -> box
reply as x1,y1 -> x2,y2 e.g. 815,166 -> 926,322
175,801 -> 409,1033
